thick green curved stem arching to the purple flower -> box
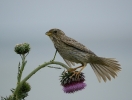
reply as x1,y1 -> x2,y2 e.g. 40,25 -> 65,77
14,61 -> 69,96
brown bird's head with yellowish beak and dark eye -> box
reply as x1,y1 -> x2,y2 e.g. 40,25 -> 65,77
45,28 -> 65,39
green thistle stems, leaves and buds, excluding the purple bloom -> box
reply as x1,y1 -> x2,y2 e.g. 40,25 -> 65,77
1,43 -> 69,100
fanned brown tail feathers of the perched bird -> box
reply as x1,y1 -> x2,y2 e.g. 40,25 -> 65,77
90,56 -> 121,82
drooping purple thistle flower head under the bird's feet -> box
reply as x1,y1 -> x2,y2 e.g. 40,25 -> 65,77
60,72 -> 86,93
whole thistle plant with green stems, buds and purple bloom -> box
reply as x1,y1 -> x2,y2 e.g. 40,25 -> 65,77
1,43 -> 86,100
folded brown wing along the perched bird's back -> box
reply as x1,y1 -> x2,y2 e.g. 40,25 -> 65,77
61,36 -> 94,54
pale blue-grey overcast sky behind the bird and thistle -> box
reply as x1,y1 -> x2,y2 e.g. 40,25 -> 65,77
0,0 -> 132,100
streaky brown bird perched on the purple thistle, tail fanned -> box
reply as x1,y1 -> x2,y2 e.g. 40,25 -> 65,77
45,28 -> 121,82
